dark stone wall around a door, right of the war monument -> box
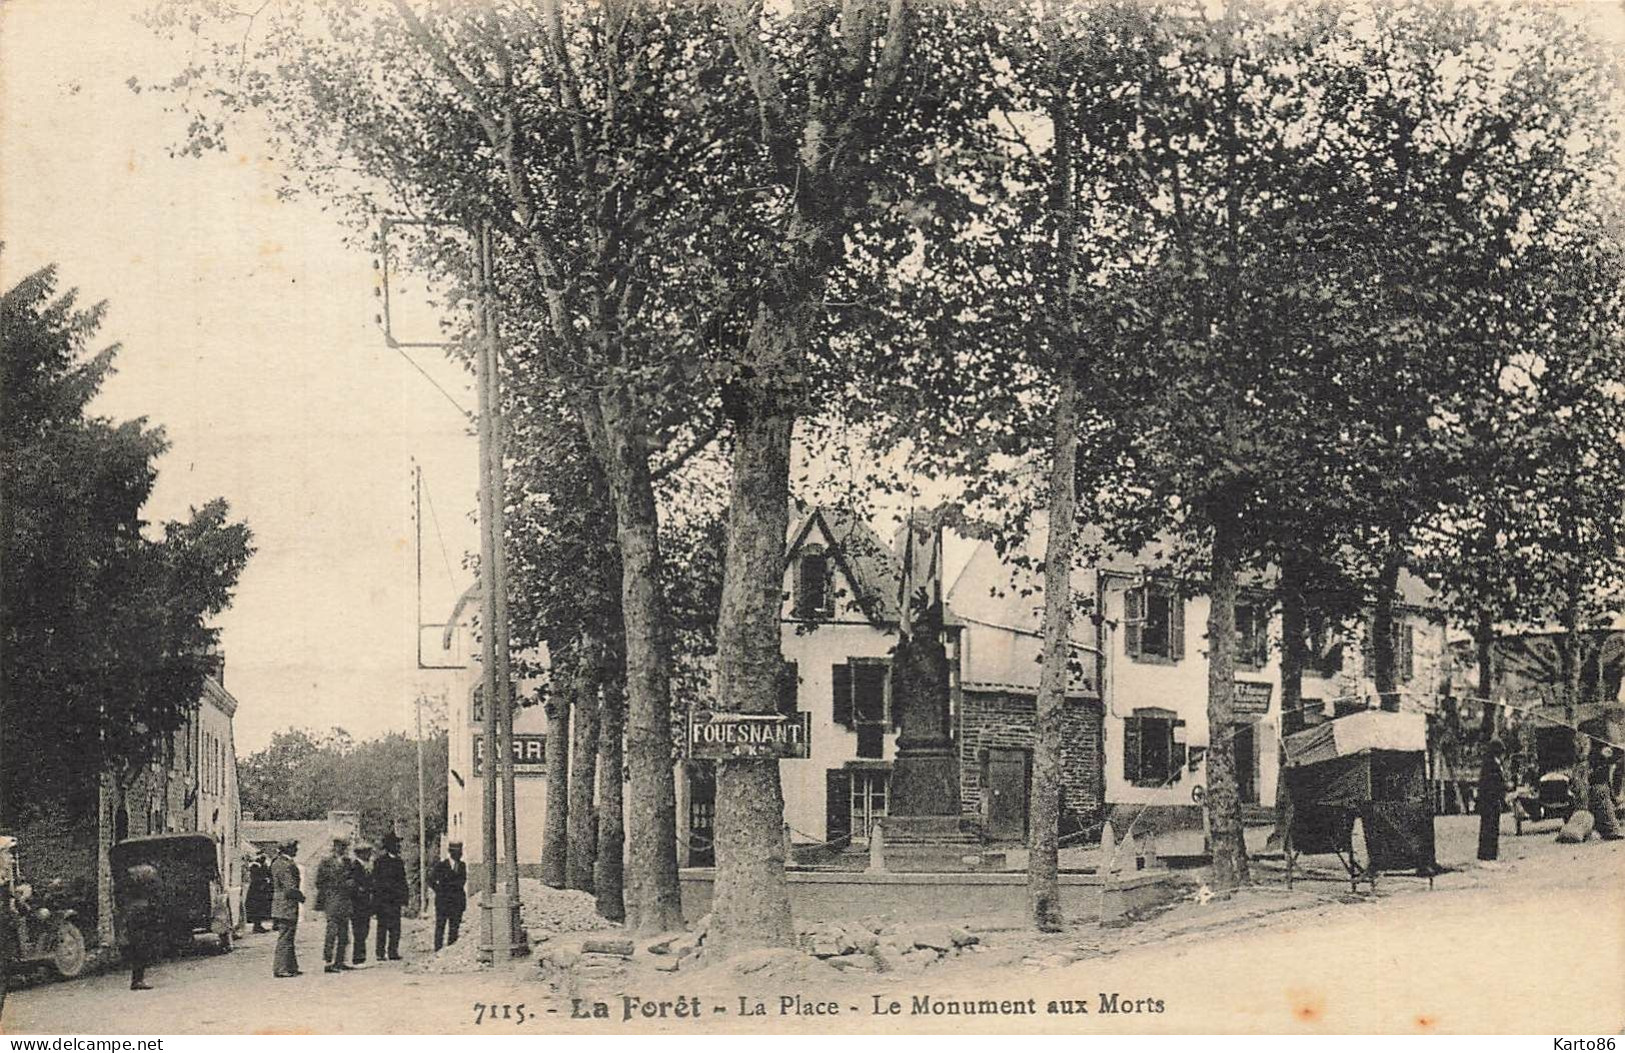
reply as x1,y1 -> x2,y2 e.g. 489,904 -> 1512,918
956,689 -> 1102,822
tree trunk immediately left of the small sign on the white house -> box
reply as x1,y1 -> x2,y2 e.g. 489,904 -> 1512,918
1206,502 -> 1250,891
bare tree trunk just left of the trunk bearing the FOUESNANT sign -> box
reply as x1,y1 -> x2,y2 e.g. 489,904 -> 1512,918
600,390 -> 683,933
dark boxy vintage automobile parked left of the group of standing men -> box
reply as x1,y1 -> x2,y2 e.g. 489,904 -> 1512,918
112,834 -> 232,954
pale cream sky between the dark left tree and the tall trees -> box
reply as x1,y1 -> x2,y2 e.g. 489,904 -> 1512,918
0,0 -> 478,754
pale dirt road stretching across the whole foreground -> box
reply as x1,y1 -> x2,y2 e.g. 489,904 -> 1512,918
0,817 -> 1625,1035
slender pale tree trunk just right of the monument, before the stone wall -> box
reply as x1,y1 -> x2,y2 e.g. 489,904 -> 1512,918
1027,361 -> 1077,933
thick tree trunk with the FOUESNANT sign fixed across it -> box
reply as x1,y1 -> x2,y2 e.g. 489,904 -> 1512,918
709,304 -> 800,954
